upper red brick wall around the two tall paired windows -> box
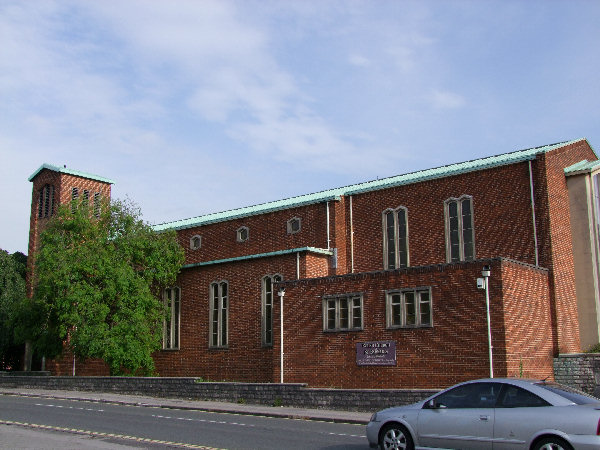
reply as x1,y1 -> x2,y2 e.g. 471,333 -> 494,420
347,163 -> 535,272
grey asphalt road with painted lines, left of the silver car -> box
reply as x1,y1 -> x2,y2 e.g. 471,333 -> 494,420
0,395 -> 369,450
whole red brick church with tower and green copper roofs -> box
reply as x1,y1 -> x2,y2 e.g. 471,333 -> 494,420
29,139 -> 600,388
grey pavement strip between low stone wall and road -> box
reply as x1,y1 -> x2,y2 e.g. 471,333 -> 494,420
0,387 -> 371,425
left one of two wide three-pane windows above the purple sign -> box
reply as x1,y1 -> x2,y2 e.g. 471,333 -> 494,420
323,294 -> 363,331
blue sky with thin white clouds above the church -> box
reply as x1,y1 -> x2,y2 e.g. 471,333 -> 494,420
0,0 -> 600,252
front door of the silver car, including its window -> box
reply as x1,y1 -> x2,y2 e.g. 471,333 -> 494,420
417,382 -> 501,450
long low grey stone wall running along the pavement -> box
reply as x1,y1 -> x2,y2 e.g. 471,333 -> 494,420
0,372 -> 437,411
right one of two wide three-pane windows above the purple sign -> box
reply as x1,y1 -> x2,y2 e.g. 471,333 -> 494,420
386,288 -> 432,328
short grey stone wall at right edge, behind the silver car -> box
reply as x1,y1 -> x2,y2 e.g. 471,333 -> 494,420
554,353 -> 600,397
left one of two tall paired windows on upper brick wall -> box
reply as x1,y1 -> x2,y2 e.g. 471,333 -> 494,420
383,206 -> 409,269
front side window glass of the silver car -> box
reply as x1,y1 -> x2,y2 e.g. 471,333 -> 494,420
433,383 -> 502,409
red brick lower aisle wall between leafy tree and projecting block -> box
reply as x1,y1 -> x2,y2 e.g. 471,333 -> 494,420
155,254 -> 296,382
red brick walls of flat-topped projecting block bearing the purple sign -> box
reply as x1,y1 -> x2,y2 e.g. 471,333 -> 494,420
273,260 -> 552,388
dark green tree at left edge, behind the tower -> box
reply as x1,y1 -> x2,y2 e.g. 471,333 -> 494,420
0,249 -> 27,370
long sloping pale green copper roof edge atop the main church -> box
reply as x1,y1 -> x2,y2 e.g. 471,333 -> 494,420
154,139 -> 585,231
